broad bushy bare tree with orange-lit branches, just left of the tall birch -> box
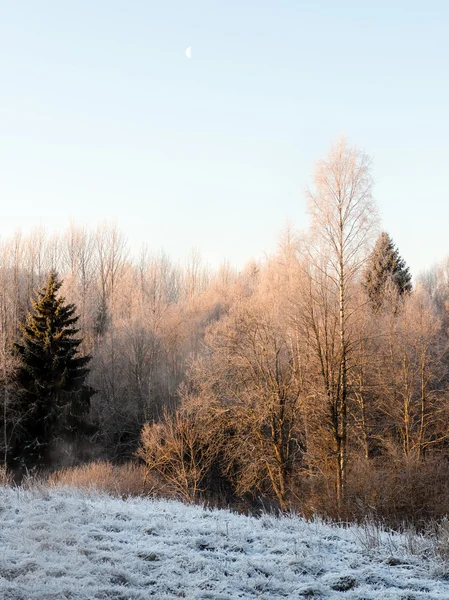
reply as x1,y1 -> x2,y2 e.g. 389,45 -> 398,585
187,294 -> 303,509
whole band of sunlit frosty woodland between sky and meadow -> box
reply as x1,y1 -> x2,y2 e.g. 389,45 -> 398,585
0,140 -> 449,519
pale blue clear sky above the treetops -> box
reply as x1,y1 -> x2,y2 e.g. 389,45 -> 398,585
0,0 -> 449,274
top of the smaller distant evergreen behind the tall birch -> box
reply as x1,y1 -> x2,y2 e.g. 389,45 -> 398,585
363,232 -> 412,310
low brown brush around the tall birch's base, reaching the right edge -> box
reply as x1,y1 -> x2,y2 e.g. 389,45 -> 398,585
294,456 -> 449,530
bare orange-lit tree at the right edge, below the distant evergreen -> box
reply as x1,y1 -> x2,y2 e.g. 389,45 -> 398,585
378,287 -> 449,458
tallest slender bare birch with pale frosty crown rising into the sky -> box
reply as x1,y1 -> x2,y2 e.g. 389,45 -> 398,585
308,139 -> 377,511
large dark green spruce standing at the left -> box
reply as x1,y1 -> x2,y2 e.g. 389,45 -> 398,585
13,271 -> 94,467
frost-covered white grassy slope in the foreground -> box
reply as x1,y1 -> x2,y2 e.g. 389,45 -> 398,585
0,488 -> 449,600
